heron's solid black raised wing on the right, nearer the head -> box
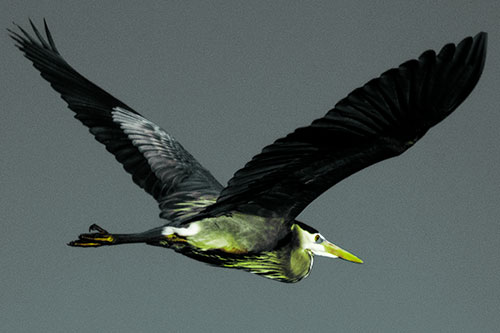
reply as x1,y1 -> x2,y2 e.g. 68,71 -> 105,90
204,33 -> 487,221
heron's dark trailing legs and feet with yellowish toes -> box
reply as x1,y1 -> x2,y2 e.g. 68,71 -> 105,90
68,224 -> 161,247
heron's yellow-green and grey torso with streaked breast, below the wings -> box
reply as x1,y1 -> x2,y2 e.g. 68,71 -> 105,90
160,216 -> 313,282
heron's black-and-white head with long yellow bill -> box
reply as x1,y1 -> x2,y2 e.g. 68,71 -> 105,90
292,221 -> 363,264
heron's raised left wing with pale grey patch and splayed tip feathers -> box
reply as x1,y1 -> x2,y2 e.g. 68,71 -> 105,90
9,21 -> 222,223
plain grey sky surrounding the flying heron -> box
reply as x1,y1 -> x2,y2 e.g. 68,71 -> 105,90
0,0 -> 500,332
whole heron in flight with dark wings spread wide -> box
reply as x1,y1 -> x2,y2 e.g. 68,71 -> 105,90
9,20 -> 487,282
